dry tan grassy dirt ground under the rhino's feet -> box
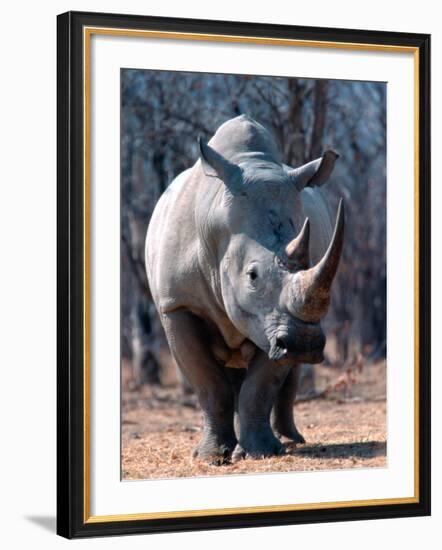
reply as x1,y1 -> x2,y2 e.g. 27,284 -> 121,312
122,362 -> 387,480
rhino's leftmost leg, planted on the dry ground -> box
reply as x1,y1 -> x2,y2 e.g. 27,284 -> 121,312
163,310 -> 237,464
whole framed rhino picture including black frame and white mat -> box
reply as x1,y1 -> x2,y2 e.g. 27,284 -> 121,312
57,12 -> 430,538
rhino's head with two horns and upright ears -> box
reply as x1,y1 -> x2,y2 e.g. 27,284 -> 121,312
200,135 -> 345,363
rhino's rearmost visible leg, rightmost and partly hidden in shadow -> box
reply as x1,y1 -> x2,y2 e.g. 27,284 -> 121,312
272,365 -> 305,443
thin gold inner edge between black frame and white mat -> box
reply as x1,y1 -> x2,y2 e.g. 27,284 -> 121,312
83,27 -> 420,523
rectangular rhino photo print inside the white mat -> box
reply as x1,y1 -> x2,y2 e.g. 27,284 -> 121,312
120,68 -> 387,480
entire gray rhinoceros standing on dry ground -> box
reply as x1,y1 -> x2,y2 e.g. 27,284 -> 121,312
146,115 -> 344,463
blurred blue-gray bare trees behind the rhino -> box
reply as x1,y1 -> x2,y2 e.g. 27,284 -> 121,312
121,69 -> 387,384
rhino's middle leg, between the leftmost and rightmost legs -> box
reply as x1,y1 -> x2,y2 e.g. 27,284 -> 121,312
235,351 -> 290,458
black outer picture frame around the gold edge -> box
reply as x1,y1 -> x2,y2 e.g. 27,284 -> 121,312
57,12 -> 431,538
